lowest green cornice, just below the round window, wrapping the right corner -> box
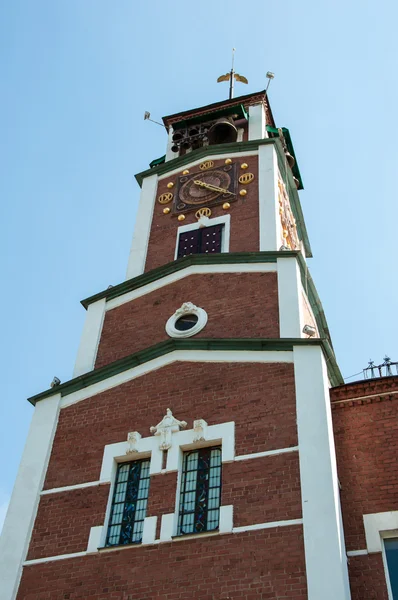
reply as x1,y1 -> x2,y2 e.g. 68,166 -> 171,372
28,338 -> 343,405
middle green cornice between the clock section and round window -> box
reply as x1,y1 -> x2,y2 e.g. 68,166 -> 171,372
81,251 -> 282,308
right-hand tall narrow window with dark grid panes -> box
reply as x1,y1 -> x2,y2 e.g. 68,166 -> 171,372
177,447 -> 221,535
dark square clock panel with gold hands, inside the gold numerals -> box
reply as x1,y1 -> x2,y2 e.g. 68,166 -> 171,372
173,164 -> 237,214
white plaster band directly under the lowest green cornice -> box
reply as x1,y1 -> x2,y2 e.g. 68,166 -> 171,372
61,350 -> 293,410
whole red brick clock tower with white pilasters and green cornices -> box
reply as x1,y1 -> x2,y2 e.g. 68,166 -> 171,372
0,91 -> 350,600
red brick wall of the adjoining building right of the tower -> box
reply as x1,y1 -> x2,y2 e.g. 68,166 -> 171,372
332,380 -> 398,550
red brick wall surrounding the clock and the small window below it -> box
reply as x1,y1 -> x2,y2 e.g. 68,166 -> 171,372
145,152 -> 259,271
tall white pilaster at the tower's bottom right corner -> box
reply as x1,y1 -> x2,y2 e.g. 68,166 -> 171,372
293,346 -> 351,600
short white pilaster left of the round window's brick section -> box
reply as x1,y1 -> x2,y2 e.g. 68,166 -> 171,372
73,298 -> 106,377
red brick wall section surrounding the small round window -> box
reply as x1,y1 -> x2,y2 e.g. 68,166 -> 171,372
96,273 -> 279,367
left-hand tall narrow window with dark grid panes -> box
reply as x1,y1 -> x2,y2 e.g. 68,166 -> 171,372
106,460 -> 149,546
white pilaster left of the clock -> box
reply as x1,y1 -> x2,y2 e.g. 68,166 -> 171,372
126,175 -> 157,279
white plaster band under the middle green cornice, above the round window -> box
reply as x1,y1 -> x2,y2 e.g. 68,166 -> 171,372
105,264 -> 277,311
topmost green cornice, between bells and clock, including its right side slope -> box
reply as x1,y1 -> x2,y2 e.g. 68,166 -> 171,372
135,138 -> 312,258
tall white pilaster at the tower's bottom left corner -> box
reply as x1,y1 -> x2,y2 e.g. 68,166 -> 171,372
0,394 -> 61,600
